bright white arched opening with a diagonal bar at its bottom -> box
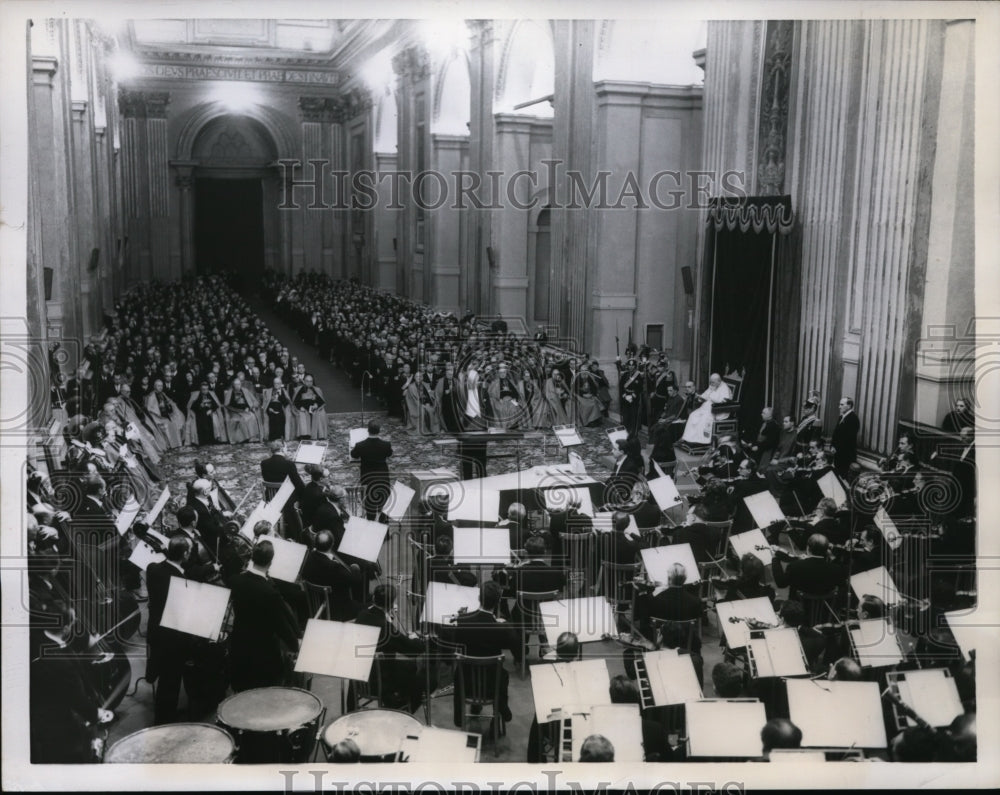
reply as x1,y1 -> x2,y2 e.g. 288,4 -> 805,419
493,20 -> 556,118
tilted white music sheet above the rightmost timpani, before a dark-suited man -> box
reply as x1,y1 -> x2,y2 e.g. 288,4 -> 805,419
295,618 -> 379,682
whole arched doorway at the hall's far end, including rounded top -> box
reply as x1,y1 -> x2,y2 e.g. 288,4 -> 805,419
192,116 -> 278,284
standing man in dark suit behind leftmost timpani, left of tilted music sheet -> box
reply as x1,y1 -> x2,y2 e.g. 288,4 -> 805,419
146,535 -> 193,725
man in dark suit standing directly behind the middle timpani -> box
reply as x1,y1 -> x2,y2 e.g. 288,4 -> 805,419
229,539 -> 299,692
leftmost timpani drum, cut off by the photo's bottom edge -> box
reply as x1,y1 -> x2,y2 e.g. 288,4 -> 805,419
104,723 -> 236,765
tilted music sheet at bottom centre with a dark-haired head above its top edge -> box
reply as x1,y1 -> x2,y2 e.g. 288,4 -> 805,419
528,659 -> 611,723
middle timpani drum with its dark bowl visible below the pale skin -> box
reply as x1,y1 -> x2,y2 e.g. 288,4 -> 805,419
218,687 -> 325,764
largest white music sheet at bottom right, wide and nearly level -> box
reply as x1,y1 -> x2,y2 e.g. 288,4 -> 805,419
785,679 -> 886,748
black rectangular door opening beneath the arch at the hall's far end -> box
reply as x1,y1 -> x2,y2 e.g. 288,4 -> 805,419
194,177 -> 264,284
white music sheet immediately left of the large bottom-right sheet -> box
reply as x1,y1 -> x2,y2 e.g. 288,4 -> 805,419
684,699 -> 767,759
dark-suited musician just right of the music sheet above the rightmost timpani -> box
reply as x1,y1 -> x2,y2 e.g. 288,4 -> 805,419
356,585 -> 426,712
